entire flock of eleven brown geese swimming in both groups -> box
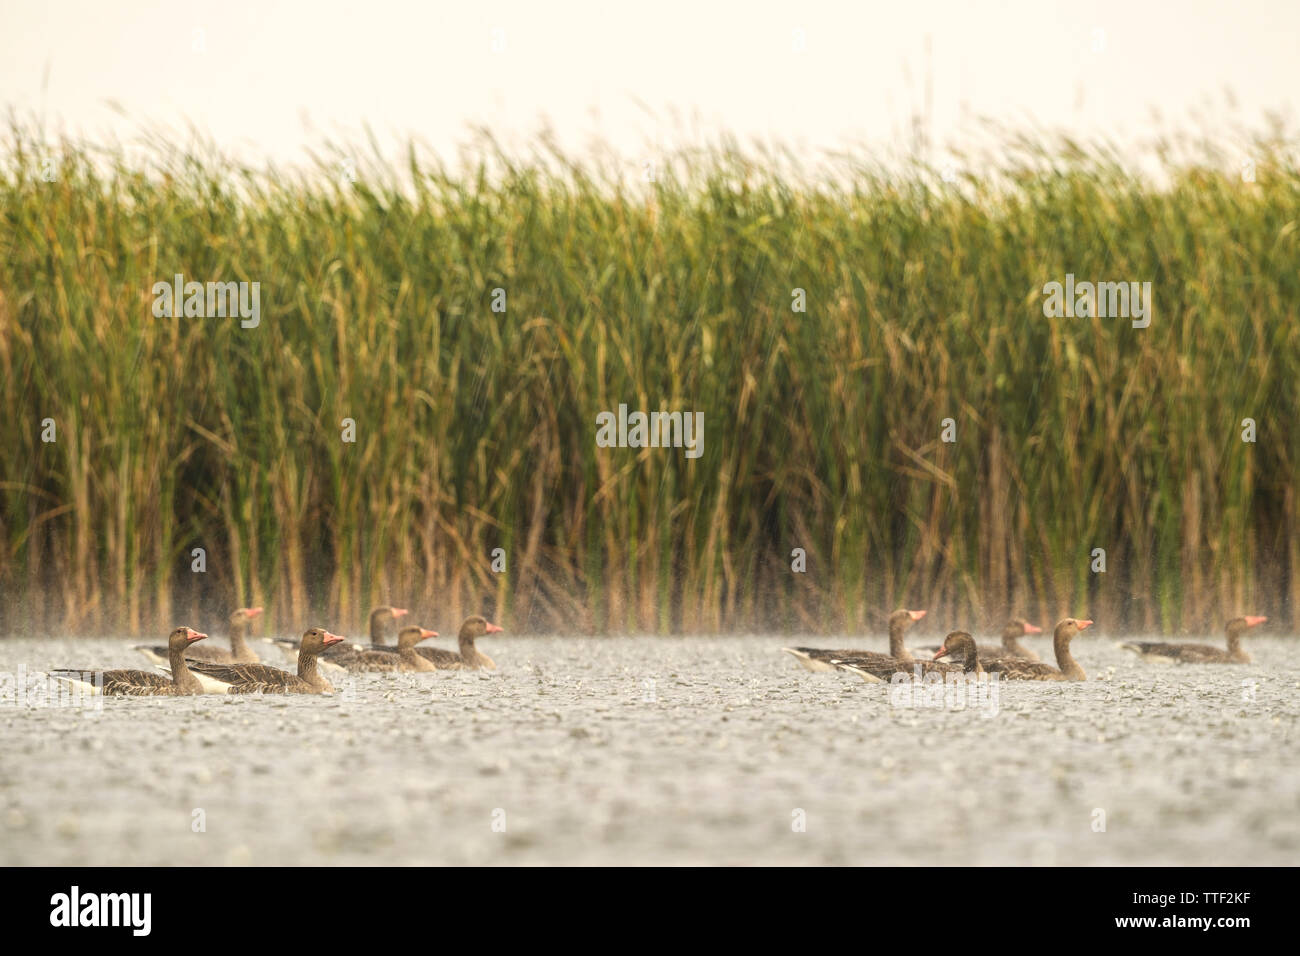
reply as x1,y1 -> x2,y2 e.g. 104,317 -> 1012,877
49,605 -> 1268,697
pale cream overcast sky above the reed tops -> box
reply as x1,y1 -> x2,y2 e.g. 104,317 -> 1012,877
0,0 -> 1300,171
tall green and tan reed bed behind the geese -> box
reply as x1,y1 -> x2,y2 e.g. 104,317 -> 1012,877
0,125 -> 1300,633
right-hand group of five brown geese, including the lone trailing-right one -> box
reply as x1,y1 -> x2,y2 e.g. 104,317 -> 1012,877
781,607 -> 1268,683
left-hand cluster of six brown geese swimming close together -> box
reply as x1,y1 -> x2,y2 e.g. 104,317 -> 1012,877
49,605 -> 502,697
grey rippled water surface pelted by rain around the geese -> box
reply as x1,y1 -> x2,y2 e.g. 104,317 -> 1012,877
0,635 -> 1300,865
